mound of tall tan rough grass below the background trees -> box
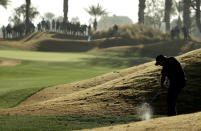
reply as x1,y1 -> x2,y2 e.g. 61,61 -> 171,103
92,24 -> 169,43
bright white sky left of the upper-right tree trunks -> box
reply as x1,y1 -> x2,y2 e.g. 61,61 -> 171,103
0,0 -> 138,27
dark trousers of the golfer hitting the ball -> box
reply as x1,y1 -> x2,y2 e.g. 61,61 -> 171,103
167,85 -> 182,116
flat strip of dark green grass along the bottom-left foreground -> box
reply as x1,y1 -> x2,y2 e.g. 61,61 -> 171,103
0,115 -> 144,131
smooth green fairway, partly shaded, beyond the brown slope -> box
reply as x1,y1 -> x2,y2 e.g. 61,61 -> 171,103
0,41 -> 200,108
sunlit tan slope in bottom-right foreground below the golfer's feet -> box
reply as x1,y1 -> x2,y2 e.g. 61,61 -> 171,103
80,112 -> 201,131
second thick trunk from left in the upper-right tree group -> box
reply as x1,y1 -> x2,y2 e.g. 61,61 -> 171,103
164,0 -> 173,31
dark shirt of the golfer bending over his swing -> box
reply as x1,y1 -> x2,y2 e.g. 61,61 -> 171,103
161,57 -> 186,86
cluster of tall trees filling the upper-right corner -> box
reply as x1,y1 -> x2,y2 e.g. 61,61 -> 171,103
138,0 -> 201,32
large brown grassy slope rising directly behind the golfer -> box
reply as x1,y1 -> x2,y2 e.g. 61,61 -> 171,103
0,45 -> 201,115
